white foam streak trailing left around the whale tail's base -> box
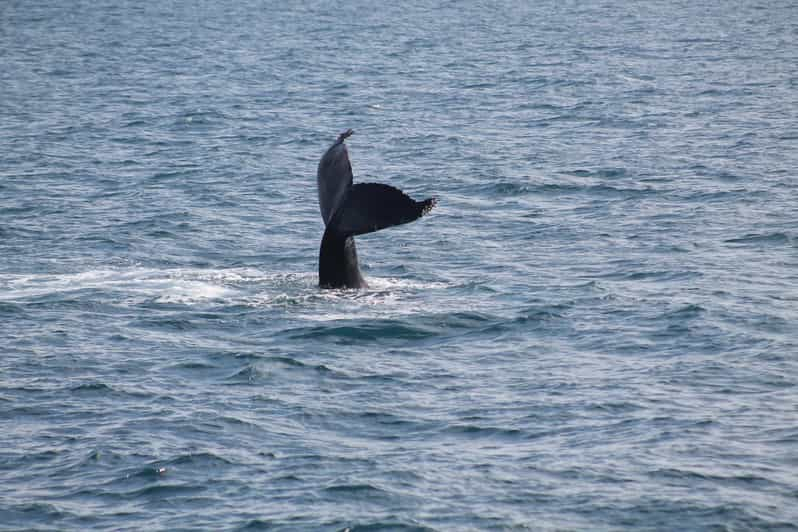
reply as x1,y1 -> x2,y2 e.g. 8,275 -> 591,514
0,267 -> 456,321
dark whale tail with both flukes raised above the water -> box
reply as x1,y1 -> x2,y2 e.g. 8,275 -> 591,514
316,129 -> 438,288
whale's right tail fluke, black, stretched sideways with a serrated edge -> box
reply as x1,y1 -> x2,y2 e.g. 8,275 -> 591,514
330,183 -> 437,235
